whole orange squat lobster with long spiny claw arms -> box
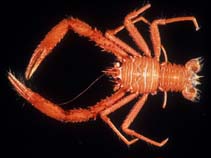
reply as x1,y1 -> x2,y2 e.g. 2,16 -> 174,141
8,4 -> 201,147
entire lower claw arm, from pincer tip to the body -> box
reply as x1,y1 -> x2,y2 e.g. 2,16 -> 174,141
8,73 -> 125,123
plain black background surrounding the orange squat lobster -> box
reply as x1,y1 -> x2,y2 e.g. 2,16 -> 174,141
0,0 -> 211,158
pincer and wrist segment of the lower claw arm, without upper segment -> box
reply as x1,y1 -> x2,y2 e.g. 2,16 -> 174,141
8,73 -> 94,122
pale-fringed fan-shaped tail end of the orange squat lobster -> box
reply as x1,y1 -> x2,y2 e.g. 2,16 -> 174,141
182,57 -> 203,101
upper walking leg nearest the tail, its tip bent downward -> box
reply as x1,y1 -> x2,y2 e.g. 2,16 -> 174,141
150,16 -> 199,61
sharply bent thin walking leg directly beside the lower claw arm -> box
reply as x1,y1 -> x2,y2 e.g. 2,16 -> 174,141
100,93 -> 138,145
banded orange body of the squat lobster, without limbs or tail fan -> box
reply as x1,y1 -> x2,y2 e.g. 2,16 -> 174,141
105,57 -> 190,94
